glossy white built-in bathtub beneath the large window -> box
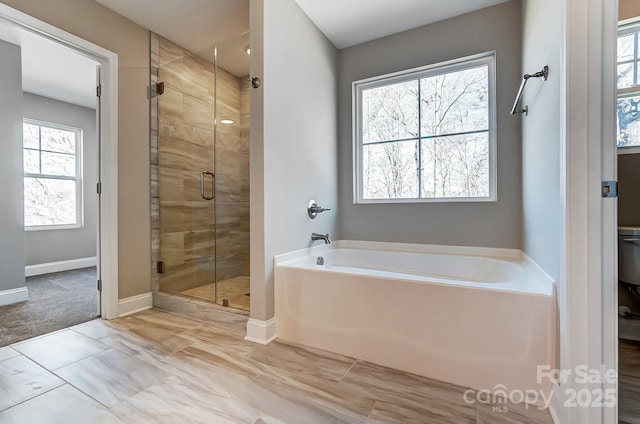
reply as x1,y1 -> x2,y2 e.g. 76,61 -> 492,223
275,241 -> 555,392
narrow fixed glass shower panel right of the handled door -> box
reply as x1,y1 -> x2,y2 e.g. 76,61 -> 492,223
214,33 -> 249,310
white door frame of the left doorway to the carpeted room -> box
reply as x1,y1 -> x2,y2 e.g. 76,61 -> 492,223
0,3 -> 118,319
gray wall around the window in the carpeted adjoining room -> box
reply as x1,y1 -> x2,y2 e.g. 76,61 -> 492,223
23,93 -> 98,265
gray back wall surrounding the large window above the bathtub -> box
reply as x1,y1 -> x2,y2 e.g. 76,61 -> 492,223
338,0 -> 522,248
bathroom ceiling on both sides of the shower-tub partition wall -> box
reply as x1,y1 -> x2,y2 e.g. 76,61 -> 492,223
96,0 -> 507,52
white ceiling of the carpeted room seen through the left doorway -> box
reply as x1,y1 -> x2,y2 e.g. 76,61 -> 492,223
0,20 -> 98,109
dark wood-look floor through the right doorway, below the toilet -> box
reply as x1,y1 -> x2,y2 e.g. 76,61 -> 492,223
618,339 -> 640,424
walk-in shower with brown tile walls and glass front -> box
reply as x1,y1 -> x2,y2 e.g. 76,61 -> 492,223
149,33 -> 250,310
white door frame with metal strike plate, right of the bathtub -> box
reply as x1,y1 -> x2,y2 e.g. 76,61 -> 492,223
554,0 -> 618,424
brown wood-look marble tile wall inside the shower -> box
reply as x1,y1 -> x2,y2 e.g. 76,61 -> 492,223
151,34 -> 249,292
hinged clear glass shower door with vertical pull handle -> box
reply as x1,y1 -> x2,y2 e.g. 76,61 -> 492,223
151,34 -> 216,301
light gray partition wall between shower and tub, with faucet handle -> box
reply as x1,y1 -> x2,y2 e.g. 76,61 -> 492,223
251,0 -> 338,320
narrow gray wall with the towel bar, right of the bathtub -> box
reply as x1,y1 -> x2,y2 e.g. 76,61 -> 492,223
517,0 -> 562,280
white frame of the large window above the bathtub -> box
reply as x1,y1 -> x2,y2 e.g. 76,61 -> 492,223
352,51 -> 498,204
